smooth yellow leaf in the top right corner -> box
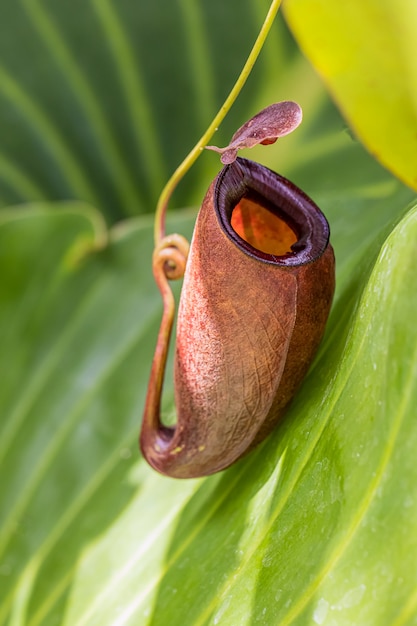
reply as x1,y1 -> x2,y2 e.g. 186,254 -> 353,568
285,0 -> 417,189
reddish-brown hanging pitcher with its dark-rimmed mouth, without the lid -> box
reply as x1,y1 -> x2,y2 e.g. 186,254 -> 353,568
140,158 -> 335,478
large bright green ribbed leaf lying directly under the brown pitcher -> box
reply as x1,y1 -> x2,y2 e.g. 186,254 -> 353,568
0,173 -> 417,626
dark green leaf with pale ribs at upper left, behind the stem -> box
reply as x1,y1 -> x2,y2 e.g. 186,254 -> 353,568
0,0 -> 292,222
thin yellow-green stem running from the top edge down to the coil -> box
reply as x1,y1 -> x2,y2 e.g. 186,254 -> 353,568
154,0 -> 281,247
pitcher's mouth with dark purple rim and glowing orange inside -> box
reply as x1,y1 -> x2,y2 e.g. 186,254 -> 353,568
214,157 -> 330,266
